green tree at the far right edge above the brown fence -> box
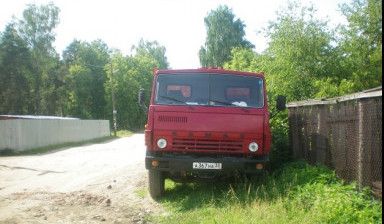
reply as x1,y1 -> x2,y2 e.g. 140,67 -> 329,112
341,0 -> 383,91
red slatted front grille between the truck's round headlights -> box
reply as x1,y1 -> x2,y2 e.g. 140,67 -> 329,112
172,138 -> 243,152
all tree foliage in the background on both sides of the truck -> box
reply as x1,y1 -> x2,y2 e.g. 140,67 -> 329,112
0,0 -> 382,133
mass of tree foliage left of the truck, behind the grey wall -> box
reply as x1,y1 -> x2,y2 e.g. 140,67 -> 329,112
0,3 -> 169,130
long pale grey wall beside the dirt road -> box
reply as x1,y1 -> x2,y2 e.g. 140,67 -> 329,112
0,119 -> 110,151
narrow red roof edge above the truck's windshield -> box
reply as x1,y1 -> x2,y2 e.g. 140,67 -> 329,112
154,68 -> 264,76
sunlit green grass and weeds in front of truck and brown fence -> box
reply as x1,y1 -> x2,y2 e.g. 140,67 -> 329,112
155,161 -> 382,223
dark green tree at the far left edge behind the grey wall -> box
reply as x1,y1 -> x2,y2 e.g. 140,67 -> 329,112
0,23 -> 33,114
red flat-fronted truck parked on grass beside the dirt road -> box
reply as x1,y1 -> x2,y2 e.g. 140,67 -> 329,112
139,68 -> 282,198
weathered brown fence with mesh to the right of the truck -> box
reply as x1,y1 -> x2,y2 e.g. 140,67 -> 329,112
287,87 -> 382,199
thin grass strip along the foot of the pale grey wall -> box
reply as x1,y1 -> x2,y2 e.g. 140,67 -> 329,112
0,130 -> 133,157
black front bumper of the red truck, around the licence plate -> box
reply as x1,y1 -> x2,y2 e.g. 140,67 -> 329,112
145,154 -> 269,175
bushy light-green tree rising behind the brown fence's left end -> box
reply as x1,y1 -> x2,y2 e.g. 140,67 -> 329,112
261,2 -> 333,100
